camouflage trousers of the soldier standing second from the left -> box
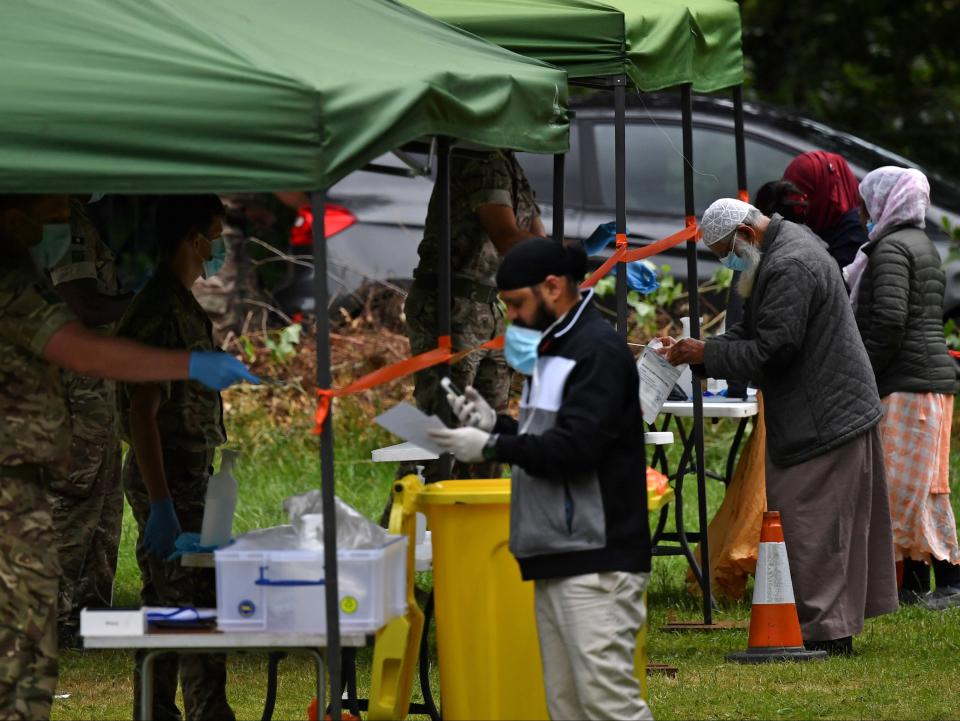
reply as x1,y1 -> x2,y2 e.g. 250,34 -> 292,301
48,435 -> 123,631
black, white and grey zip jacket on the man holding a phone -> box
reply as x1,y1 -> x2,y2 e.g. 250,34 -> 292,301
495,295 -> 650,579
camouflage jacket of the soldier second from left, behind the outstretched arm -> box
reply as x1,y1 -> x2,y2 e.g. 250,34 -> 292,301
50,199 -> 118,443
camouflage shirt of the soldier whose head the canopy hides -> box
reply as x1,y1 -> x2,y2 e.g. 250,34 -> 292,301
414,150 -> 540,286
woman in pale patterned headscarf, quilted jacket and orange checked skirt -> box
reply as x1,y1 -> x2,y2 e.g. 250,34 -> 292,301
847,167 -> 960,608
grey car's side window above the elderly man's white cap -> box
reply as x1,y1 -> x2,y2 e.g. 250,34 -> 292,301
593,123 -> 793,215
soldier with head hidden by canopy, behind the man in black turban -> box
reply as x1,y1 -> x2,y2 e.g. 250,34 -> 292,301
401,151 -> 544,482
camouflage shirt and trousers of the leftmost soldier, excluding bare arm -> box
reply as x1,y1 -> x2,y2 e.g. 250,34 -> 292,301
0,195 -> 75,719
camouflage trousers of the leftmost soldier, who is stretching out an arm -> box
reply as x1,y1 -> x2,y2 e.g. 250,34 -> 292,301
0,466 -> 60,719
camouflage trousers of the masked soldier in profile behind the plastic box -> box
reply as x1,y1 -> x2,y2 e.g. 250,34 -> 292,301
123,449 -> 235,721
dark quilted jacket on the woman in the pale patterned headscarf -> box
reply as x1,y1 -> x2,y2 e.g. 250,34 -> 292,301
856,228 -> 957,397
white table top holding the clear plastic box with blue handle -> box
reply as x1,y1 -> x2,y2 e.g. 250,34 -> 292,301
83,630 -> 367,650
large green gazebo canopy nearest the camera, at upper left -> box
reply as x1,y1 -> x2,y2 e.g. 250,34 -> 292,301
0,0 -> 569,193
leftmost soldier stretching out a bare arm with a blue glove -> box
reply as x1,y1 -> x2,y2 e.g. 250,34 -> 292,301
0,195 -> 257,720
